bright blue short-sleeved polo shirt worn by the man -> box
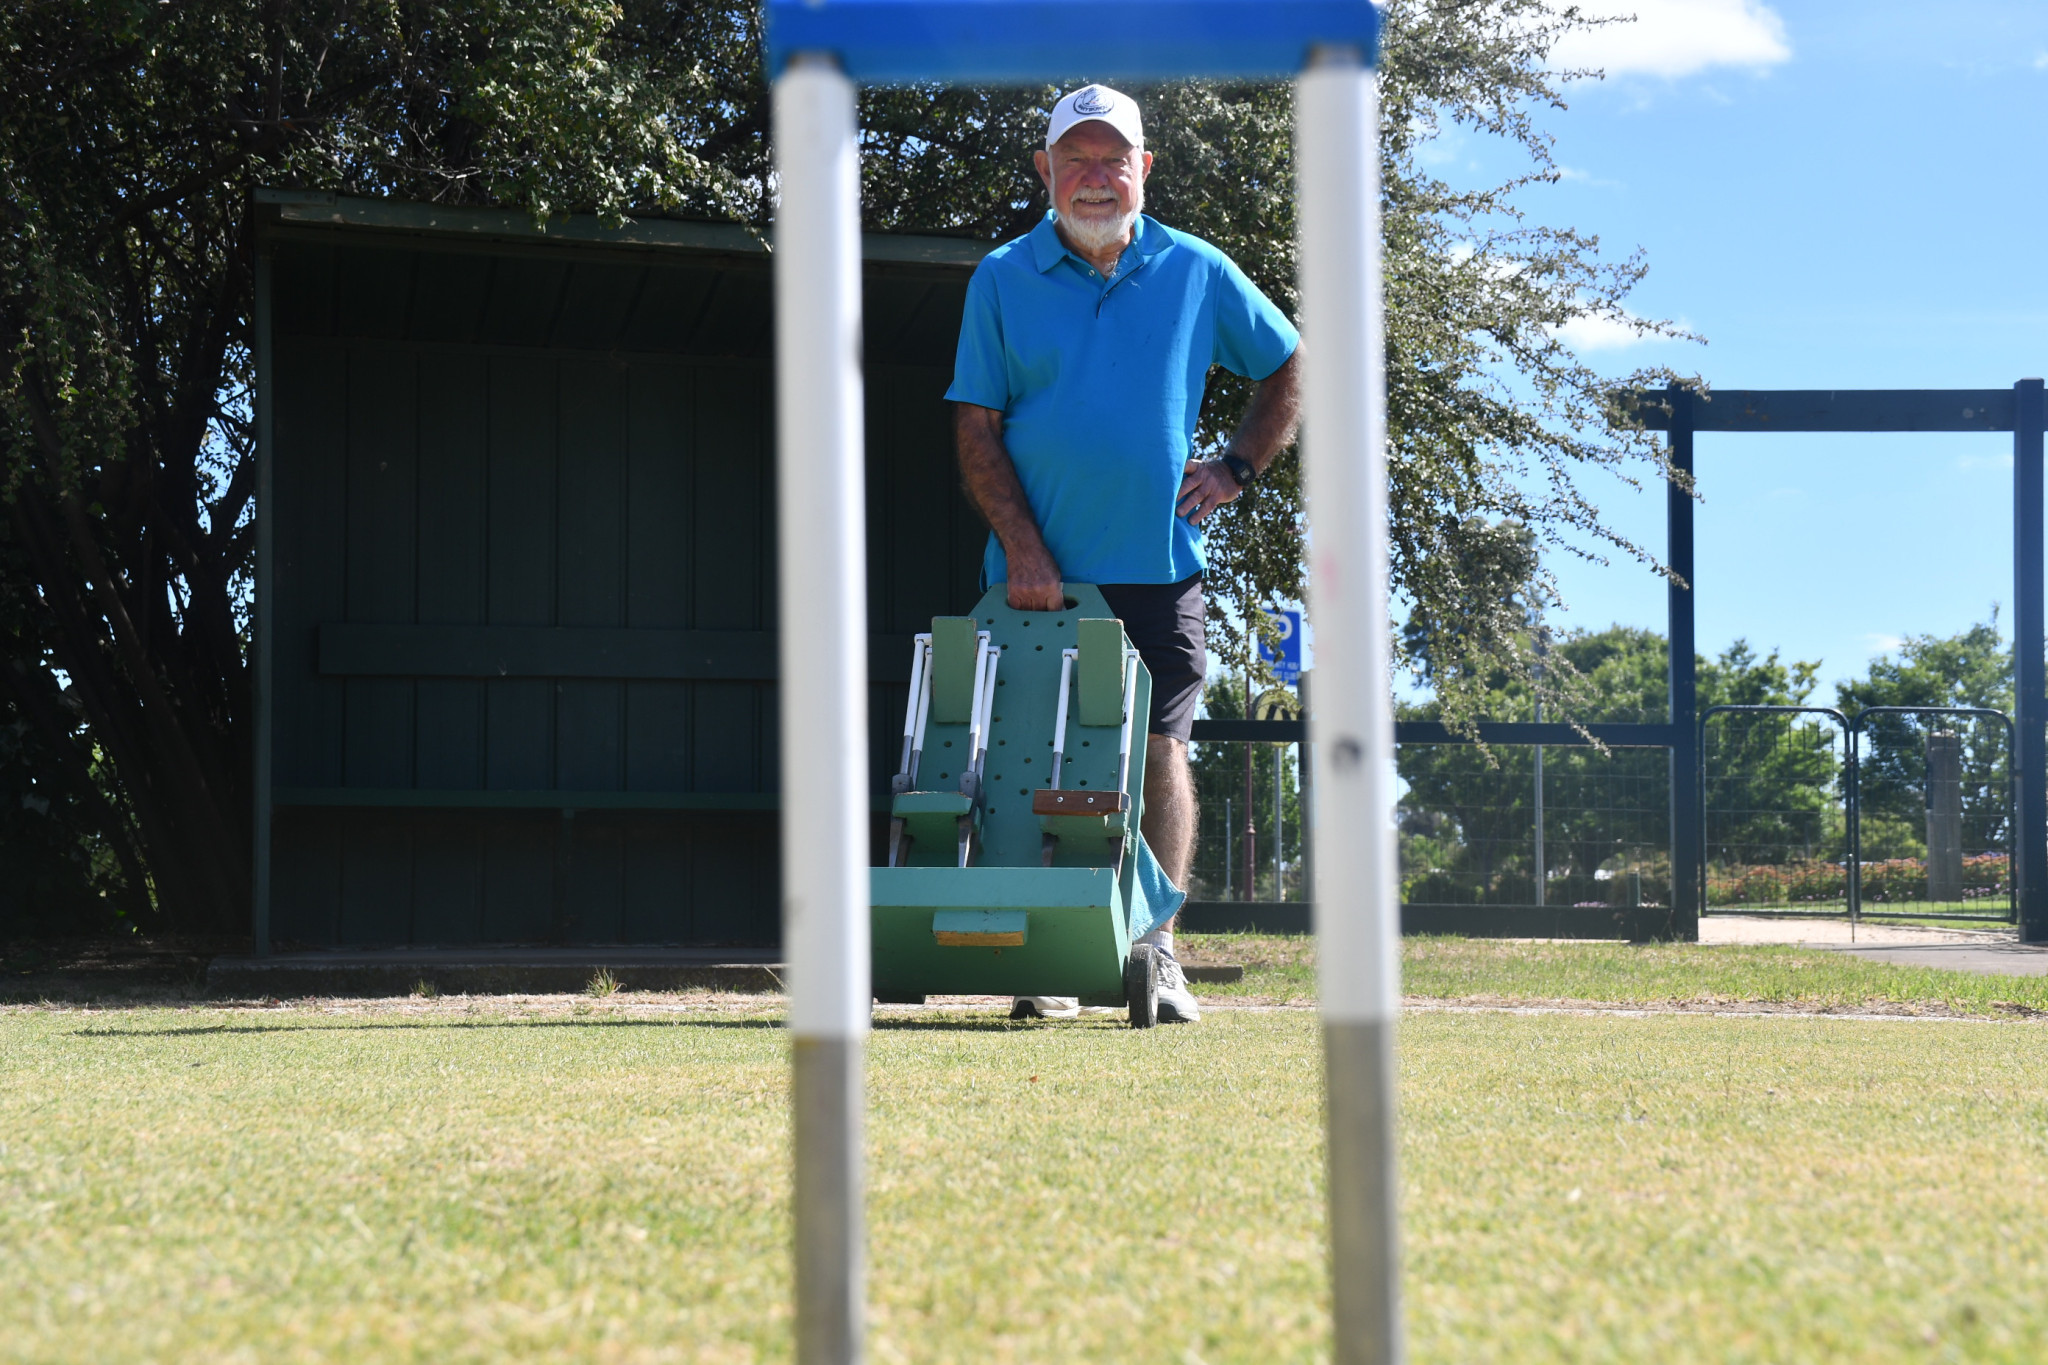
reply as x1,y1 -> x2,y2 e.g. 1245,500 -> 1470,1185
946,213 -> 1300,583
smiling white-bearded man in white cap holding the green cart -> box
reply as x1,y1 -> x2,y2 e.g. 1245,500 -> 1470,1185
946,86 -> 1298,1023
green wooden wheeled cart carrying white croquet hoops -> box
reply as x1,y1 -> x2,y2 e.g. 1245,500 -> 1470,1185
870,583 -> 1178,1027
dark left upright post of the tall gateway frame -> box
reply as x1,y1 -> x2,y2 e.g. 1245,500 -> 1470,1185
1662,385 -> 1706,941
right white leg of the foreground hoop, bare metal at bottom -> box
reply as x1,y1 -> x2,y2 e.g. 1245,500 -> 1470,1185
1294,49 -> 1405,1365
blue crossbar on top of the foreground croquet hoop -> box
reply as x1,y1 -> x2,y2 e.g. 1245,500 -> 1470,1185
766,0 -> 1380,84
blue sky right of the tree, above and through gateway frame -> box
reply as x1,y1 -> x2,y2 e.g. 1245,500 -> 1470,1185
1440,0 -> 2048,692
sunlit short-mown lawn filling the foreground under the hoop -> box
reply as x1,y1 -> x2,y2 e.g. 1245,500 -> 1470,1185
0,994 -> 2048,1365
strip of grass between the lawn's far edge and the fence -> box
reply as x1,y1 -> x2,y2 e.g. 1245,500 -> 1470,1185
1178,933 -> 2048,1017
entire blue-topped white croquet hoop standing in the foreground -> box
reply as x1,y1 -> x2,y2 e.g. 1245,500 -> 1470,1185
766,0 -> 1403,1365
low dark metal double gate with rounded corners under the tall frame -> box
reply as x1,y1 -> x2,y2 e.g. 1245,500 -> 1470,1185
1698,706 -> 2017,923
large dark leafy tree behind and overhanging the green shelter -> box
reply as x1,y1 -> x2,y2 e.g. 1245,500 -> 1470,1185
0,0 -> 1687,929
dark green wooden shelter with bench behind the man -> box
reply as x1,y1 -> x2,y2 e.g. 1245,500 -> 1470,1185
258,201 -> 983,948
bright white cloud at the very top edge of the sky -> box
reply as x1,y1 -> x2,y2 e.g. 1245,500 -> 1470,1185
1550,0 -> 1792,78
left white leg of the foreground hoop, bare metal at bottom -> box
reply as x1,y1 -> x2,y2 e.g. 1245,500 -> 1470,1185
774,55 -> 872,1365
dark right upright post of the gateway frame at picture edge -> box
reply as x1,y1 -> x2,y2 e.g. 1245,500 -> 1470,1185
2013,379 -> 2048,943
